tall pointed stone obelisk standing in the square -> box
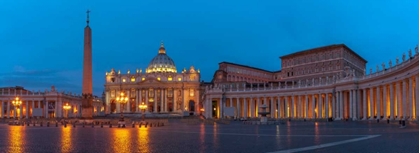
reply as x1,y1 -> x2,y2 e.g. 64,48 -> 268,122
82,10 -> 93,119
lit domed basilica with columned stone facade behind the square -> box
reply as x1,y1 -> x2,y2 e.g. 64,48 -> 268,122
105,43 -> 200,114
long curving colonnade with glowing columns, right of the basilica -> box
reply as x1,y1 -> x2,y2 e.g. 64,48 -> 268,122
204,74 -> 419,120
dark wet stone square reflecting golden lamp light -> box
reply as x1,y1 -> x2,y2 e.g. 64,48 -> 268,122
0,120 -> 419,153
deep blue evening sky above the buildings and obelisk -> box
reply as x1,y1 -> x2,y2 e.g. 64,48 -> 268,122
0,0 -> 419,95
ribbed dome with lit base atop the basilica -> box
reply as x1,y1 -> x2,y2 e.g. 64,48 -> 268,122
146,42 -> 176,73
